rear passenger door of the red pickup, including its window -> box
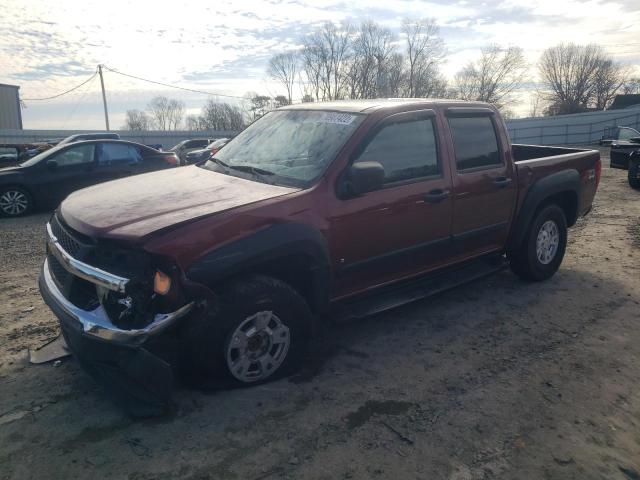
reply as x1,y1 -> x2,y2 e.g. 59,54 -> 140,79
446,108 -> 516,257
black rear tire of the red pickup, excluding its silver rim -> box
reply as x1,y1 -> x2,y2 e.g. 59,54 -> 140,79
508,204 -> 567,282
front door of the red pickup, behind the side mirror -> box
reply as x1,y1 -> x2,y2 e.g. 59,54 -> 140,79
330,110 -> 452,297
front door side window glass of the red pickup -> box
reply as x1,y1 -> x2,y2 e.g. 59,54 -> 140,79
355,118 -> 440,183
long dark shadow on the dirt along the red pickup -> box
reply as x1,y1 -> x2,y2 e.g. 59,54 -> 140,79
0,268 -> 633,468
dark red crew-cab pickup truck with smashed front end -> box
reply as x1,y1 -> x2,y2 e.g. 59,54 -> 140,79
39,99 -> 601,414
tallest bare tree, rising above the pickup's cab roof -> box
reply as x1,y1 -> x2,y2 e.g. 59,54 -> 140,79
402,18 -> 445,97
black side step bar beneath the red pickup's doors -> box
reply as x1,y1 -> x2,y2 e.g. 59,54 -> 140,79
331,255 -> 509,322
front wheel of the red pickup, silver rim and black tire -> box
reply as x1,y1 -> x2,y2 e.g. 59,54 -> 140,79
180,275 -> 312,387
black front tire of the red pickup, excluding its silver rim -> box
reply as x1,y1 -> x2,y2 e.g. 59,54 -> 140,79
182,275 -> 312,388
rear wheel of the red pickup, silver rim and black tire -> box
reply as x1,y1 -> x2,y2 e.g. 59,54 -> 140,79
509,205 -> 567,281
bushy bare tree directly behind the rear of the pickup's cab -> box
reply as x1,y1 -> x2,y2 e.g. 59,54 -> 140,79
455,45 -> 527,108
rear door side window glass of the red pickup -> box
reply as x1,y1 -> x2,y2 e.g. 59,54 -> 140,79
449,116 -> 502,170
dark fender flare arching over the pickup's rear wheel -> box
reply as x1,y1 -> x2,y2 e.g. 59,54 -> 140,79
507,169 -> 580,251
